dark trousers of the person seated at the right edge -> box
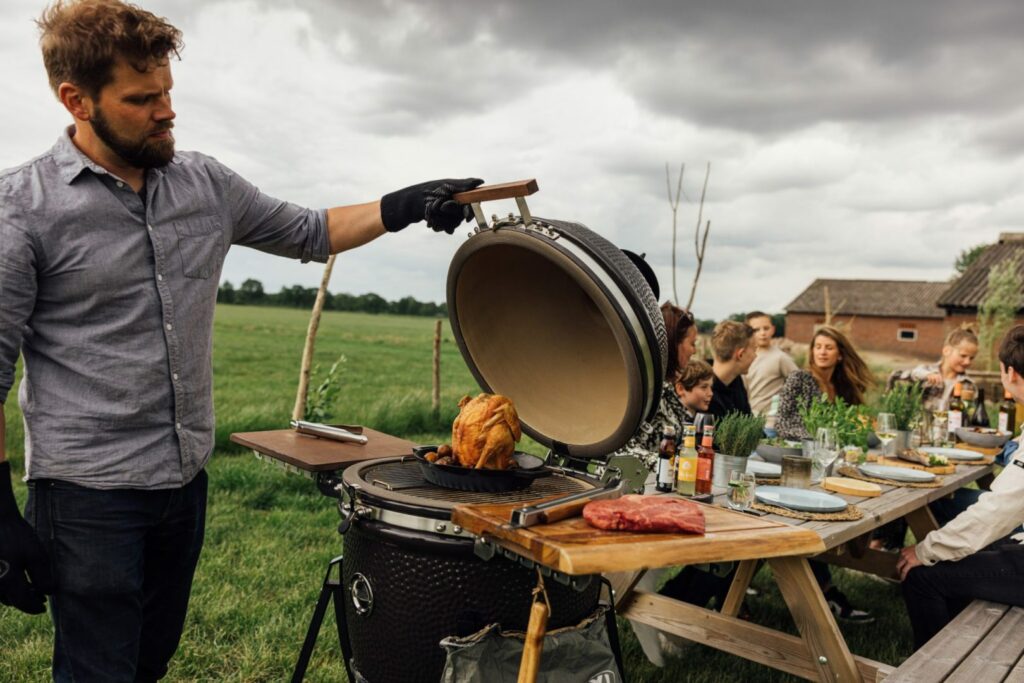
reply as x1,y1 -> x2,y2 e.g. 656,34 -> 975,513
903,539 -> 1024,649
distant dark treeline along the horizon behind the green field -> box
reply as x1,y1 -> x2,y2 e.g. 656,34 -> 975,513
217,278 -> 785,337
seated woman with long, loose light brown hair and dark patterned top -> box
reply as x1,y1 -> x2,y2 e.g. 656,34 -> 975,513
775,326 -> 874,624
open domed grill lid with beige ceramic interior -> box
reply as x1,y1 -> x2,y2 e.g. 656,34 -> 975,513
446,214 -> 667,458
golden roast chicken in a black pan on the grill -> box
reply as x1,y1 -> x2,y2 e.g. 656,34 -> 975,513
413,393 -> 551,493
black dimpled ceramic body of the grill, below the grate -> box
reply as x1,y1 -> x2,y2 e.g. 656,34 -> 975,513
335,459 -> 600,683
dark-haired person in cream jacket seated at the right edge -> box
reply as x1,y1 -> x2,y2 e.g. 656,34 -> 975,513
897,325 -> 1024,649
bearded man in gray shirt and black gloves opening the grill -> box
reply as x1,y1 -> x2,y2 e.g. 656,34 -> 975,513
0,0 -> 481,681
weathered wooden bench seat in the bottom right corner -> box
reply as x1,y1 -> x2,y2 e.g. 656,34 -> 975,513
885,600 -> 1024,683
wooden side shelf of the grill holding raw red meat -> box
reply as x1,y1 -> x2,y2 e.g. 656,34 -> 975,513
452,503 -> 825,575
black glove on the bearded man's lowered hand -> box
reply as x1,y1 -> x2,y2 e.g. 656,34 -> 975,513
0,462 -> 54,614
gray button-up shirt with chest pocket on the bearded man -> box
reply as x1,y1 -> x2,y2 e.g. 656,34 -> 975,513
0,129 -> 329,488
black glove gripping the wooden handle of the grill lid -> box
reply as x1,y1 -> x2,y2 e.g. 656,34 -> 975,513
381,178 -> 483,234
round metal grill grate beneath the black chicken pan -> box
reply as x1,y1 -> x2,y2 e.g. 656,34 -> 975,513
360,461 -> 594,505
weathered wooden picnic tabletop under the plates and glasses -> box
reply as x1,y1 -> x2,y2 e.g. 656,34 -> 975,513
715,456 -> 992,550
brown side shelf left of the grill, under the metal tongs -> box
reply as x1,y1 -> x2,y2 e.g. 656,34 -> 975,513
231,429 -> 416,472
